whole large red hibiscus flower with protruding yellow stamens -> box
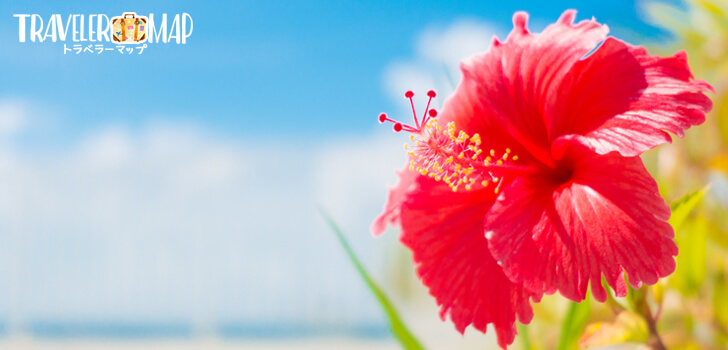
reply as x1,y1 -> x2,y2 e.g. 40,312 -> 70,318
372,11 -> 712,347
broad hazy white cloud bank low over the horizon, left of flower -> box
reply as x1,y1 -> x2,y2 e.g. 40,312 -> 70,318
0,121 -> 404,334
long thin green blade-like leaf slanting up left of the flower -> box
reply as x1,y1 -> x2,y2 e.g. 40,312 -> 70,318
321,211 -> 424,350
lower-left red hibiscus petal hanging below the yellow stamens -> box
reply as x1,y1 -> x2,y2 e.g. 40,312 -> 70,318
400,176 -> 540,348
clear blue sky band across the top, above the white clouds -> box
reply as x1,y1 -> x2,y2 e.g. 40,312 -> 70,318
0,1 -> 676,144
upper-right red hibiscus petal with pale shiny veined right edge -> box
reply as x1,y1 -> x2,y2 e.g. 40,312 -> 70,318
547,38 -> 713,159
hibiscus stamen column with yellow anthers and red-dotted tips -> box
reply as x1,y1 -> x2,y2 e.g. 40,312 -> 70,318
379,90 -> 532,194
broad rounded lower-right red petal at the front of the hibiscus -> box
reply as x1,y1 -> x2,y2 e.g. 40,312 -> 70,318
485,149 -> 677,301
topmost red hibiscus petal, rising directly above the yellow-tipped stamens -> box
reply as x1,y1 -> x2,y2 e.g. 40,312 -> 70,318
456,10 -> 608,164
